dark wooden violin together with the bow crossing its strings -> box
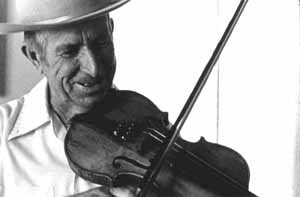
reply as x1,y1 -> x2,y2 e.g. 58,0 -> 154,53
64,0 -> 256,197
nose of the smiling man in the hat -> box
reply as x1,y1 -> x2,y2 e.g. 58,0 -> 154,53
81,47 -> 100,77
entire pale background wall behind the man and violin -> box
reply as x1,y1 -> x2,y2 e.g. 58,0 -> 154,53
0,0 -> 300,197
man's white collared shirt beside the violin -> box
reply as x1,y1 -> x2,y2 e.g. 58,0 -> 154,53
0,79 -> 96,197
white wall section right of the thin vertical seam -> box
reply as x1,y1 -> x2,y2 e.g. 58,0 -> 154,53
220,0 -> 300,197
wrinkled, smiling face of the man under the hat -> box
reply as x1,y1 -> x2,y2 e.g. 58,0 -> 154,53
42,17 -> 116,113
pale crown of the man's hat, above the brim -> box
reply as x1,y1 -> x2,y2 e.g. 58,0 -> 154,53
9,0 -> 118,24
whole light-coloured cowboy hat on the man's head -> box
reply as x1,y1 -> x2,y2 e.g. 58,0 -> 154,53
0,0 -> 129,34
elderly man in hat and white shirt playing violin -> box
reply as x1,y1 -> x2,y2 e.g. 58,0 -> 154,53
0,0 -> 138,197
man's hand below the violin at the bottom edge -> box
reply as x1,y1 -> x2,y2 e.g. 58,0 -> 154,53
69,187 -> 137,197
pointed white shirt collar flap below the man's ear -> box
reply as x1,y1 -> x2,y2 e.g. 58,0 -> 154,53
8,78 -> 51,140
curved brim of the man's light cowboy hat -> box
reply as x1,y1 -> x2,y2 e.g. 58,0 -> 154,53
0,0 -> 129,34
